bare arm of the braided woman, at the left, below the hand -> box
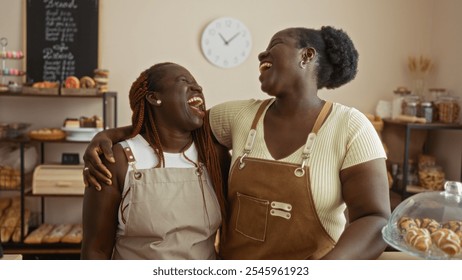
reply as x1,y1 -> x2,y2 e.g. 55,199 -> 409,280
81,145 -> 128,259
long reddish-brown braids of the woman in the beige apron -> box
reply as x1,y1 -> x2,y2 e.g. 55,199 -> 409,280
129,62 -> 226,220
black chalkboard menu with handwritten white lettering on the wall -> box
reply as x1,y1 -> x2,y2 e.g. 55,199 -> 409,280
26,0 -> 99,82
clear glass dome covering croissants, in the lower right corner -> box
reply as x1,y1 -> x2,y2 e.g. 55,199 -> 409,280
382,181 -> 462,260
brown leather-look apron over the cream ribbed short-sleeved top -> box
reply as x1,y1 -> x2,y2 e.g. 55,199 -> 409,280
220,100 -> 335,259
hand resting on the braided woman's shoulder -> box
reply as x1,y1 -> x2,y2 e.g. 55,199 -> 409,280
83,126 -> 132,190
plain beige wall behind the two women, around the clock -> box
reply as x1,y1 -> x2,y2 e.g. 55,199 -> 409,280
0,0 -> 462,223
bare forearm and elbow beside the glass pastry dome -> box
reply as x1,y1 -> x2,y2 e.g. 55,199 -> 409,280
324,159 -> 391,260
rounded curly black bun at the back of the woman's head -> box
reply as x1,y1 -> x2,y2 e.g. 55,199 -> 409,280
321,26 -> 359,89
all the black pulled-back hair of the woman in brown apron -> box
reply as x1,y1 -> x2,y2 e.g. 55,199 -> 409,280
294,26 -> 359,89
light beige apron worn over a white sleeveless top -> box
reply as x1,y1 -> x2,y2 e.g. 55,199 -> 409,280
113,143 -> 221,260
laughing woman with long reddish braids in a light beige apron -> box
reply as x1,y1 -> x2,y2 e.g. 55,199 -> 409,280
81,63 -> 229,259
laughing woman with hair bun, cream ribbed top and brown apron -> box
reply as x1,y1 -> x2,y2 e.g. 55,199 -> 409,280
84,26 -> 390,259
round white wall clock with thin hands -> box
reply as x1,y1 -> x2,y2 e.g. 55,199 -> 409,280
201,17 -> 252,68
